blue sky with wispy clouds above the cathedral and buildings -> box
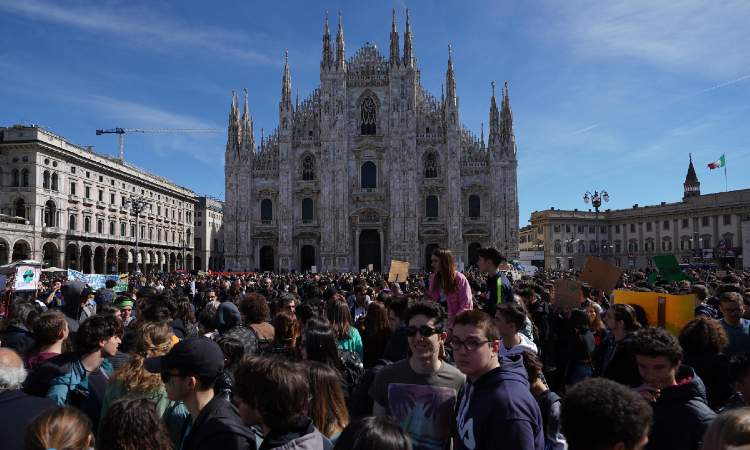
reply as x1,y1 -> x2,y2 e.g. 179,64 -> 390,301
0,0 -> 750,225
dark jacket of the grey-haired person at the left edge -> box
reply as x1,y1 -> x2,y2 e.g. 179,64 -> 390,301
0,390 -> 57,450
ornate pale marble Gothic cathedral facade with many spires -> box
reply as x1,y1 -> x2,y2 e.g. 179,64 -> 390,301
224,11 -> 518,271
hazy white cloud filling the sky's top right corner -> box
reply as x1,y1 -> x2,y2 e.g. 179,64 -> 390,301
550,0 -> 750,79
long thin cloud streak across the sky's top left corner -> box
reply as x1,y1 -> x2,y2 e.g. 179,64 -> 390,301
0,0 -> 280,66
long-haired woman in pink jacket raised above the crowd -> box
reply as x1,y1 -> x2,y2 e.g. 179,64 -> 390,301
427,248 -> 474,332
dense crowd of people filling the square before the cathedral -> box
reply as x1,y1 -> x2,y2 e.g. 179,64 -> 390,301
0,248 -> 750,450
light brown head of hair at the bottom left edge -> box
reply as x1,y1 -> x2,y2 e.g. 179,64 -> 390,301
23,406 -> 94,450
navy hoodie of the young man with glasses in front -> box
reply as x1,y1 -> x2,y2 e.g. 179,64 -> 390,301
453,355 -> 544,450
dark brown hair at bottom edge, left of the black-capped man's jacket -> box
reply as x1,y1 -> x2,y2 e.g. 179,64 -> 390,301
97,398 -> 172,450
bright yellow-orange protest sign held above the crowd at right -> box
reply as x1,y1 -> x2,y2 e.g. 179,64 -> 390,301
614,290 -> 695,336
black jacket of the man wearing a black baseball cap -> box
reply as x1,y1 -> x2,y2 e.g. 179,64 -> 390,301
182,397 -> 256,450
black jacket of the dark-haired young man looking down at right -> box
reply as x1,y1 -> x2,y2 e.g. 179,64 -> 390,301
646,366 -> 716,450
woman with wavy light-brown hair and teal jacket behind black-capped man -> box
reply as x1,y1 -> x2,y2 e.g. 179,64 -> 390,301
102,322 -> 189,447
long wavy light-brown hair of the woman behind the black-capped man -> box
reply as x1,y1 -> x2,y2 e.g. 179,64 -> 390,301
112,322 -> 172,393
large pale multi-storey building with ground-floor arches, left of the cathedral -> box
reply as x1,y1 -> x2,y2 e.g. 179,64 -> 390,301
0,126 -> 195,274
